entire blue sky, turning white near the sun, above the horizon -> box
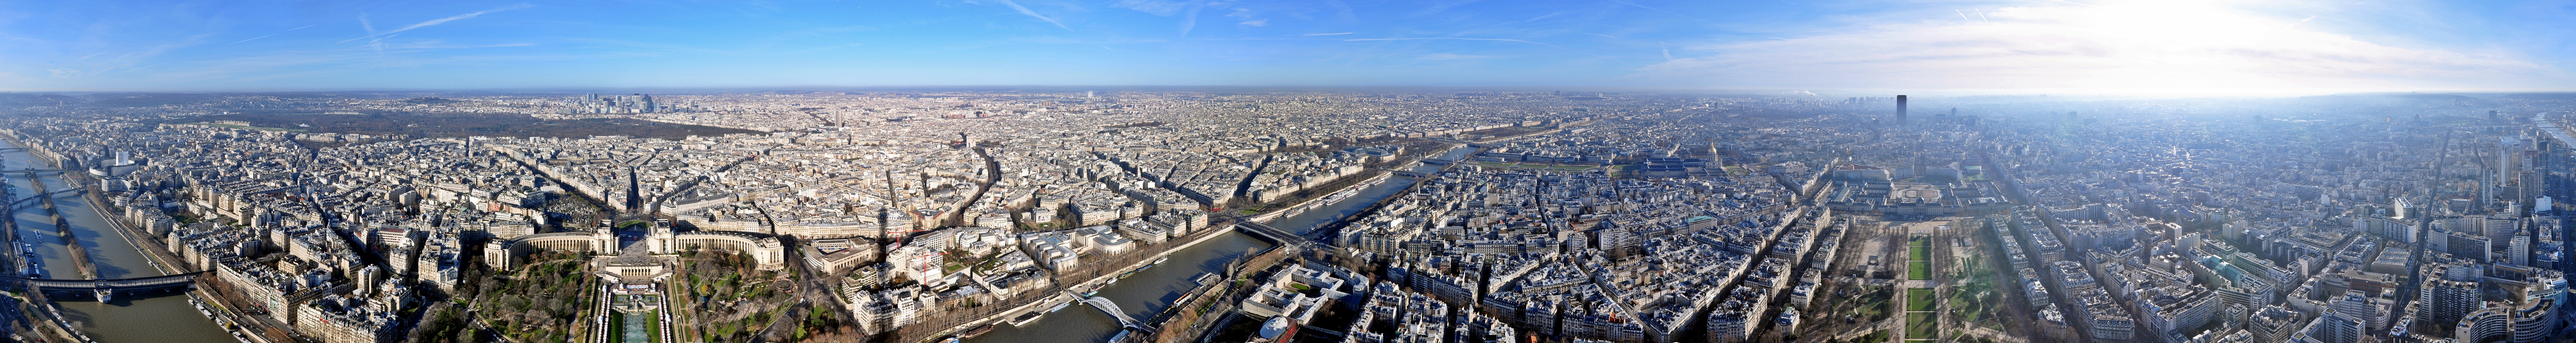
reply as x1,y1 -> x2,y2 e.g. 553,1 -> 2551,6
0,0 -> 2576,95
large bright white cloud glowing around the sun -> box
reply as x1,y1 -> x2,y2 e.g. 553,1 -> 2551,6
1633,0 -> 2566,95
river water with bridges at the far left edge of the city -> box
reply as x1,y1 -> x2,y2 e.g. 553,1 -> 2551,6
0,142 -> 235,343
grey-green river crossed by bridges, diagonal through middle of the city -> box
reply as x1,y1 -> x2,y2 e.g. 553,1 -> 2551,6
966,147 -> 1473,343
